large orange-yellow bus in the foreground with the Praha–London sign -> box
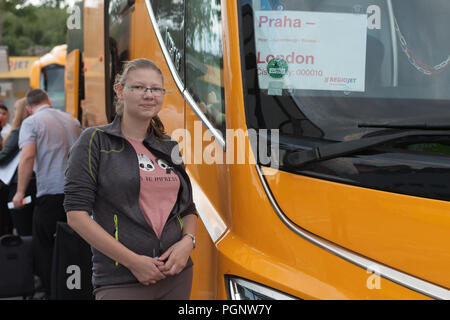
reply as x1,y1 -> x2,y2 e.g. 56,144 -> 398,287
69,0 -> 450,300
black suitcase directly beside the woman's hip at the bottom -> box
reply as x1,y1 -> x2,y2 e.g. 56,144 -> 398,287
51,222 -> 94,300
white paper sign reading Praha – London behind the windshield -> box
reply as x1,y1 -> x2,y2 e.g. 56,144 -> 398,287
255,11 -> 367,91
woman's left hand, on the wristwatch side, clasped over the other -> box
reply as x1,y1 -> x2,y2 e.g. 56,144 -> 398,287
158,237 -> 193,276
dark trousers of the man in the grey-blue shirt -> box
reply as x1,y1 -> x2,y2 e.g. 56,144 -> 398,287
33,194 -> 67,296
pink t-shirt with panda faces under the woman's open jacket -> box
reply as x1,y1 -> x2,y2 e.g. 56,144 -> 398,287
127,138 -> 180,238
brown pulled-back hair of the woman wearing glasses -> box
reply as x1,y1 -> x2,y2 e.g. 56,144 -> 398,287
114,58 -> 166,138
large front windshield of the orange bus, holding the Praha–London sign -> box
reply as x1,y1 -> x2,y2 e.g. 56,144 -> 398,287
240,0 -> 450,200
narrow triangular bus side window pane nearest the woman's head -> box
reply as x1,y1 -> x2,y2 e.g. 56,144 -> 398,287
151,0 -> 185,82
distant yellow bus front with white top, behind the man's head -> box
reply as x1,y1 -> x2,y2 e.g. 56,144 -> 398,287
30,44 -> 67,111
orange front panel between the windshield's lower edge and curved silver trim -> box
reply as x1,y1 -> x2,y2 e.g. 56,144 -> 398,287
266,171 -> 450,287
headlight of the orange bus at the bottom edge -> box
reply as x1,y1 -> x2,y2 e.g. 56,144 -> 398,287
225,276 -> 298,300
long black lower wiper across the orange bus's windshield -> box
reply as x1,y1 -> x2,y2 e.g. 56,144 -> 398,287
285,130 -> 450,168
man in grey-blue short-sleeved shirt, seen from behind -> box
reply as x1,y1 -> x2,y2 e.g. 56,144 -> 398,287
13,89 -> 81,296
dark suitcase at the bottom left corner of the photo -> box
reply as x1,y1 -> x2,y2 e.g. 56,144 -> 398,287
0,234 -> 34,298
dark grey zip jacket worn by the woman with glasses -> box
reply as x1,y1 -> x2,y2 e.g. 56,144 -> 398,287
64,117 -> 196,287
